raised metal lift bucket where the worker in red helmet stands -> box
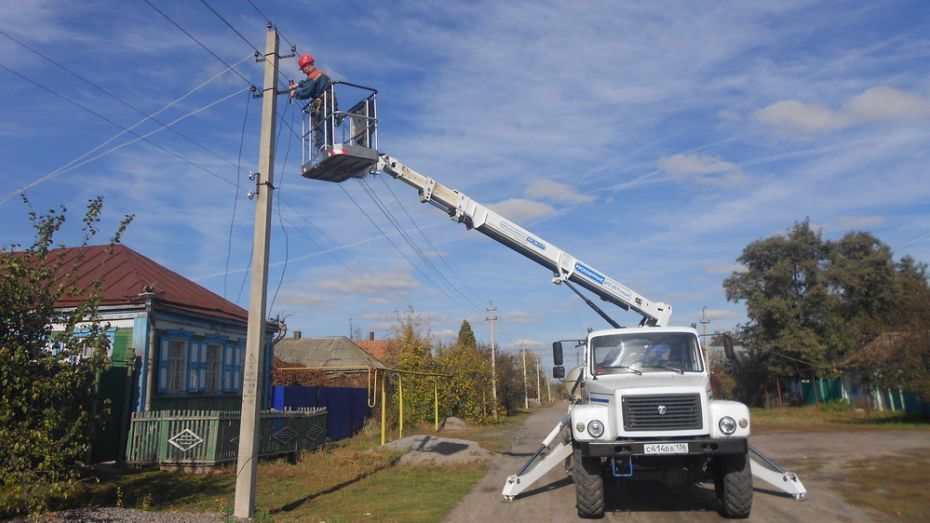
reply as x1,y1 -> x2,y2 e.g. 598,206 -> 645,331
300,82 -> 379,182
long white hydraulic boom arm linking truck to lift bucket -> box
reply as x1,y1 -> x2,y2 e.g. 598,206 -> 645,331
377,155 -> 672,327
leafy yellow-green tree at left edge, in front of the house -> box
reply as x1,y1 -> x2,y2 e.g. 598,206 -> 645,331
0,197 -> 132,514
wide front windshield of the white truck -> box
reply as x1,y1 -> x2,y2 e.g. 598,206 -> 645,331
591,332 -> 703,375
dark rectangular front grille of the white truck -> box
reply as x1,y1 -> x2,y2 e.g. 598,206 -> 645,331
622,394 -> 703,432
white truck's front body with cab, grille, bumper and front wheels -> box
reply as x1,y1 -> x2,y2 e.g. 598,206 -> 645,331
553,327 -> 752,517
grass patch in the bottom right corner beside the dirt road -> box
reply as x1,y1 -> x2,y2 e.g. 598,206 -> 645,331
838,450 -> 930,521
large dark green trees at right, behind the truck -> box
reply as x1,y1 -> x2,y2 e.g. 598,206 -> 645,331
723,220 -> 930,404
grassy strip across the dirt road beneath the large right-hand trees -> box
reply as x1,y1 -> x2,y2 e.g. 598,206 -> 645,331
751,403 -> 930,434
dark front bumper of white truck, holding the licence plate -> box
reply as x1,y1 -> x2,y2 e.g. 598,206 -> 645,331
579,438 -> 748,458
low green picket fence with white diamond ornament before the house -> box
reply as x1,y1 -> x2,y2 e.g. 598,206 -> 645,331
126,408 -> 327,467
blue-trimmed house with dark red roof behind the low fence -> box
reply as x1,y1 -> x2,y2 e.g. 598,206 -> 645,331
40,245 -> 277,461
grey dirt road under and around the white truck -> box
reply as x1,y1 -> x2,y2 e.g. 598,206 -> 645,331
446,403 -> 930,523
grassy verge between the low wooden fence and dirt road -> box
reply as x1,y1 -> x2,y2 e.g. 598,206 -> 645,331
34,411 -> 544,523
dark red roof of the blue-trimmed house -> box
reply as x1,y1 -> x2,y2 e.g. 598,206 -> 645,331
48,245 -> 249,322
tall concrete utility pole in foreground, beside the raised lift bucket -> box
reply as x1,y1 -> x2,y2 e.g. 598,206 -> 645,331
235,24 -> 278,518
